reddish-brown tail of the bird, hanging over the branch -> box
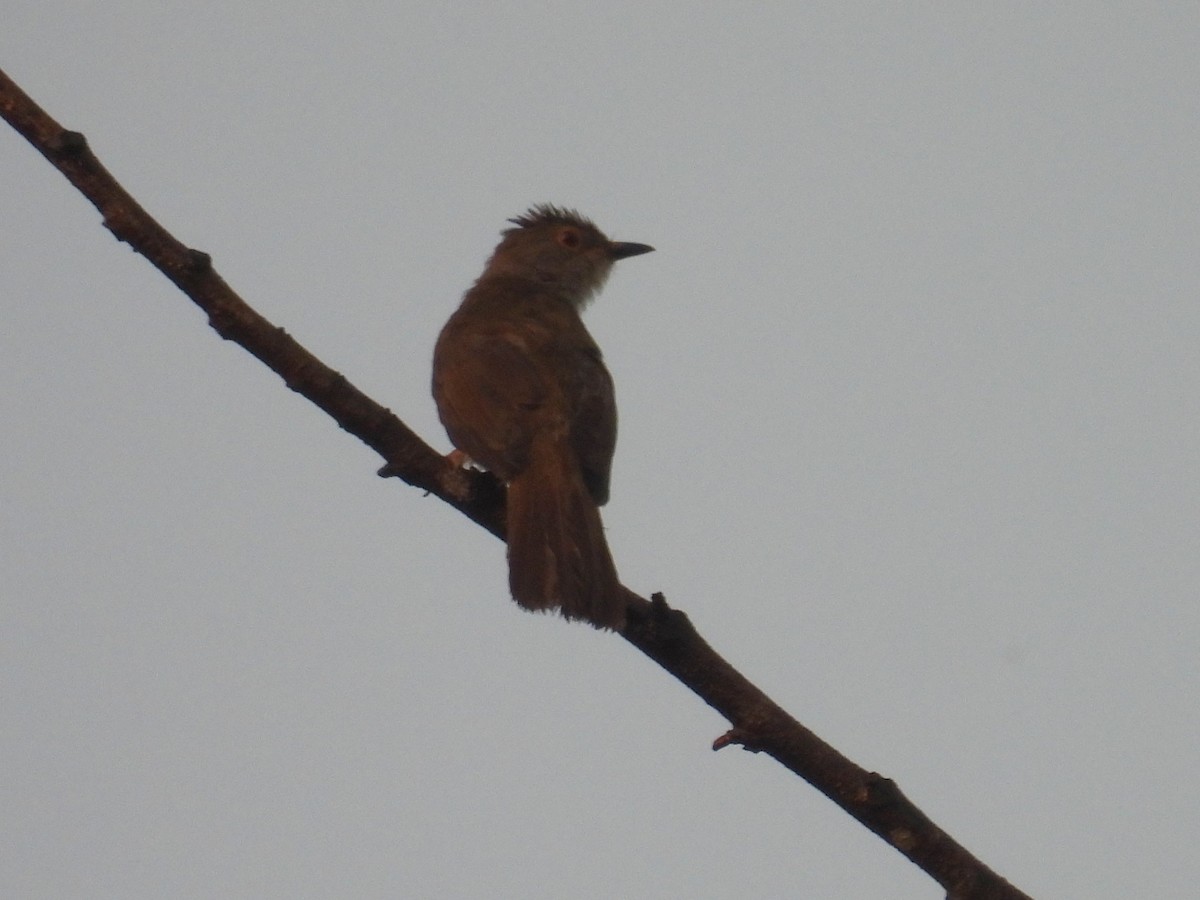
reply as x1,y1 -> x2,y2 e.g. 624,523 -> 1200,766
506,440 -> 625,630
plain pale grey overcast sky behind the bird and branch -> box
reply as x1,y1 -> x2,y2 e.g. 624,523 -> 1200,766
0,0 -> 1200,900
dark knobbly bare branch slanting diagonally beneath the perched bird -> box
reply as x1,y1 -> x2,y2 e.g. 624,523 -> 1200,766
0,71 -> 1028,900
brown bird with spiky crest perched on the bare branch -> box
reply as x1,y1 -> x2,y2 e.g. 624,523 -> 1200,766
433,205 -> 654,630
